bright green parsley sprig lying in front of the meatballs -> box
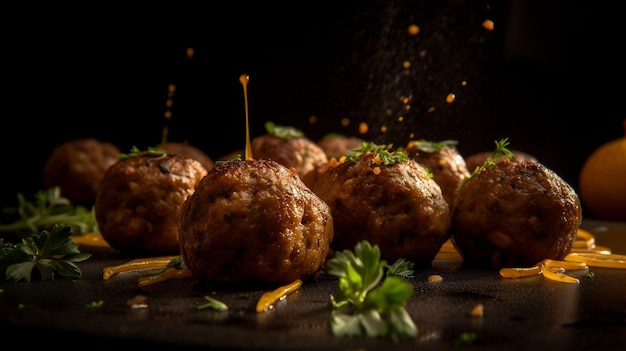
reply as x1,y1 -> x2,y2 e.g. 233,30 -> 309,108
326,241 -> 417,342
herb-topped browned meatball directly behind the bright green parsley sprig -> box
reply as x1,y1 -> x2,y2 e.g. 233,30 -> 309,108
313,153 -> 450,267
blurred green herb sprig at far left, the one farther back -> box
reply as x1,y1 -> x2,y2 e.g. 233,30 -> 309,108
0,186 -> 98,235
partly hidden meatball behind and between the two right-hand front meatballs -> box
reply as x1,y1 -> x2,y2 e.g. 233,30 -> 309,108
406,140 -> 470,206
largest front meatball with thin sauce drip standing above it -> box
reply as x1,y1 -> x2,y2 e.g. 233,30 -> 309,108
179,159 -> 334,284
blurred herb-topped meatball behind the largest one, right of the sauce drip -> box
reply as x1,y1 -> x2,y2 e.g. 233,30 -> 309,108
250,122 -> 328,177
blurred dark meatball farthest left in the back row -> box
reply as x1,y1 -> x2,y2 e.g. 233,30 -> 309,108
43,138 -> 120,204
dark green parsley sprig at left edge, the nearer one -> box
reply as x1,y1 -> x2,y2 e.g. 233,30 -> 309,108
0,225 -> 91,281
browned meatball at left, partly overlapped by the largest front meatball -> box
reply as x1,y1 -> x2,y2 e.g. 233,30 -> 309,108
95,155 -> 207,256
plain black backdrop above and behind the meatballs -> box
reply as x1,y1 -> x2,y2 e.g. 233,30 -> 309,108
0,0 -> 624,214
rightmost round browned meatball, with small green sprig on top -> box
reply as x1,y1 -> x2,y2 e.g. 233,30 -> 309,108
452,158 -> 582,268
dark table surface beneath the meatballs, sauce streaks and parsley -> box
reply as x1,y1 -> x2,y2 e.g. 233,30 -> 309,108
0,220 -> 626,350
